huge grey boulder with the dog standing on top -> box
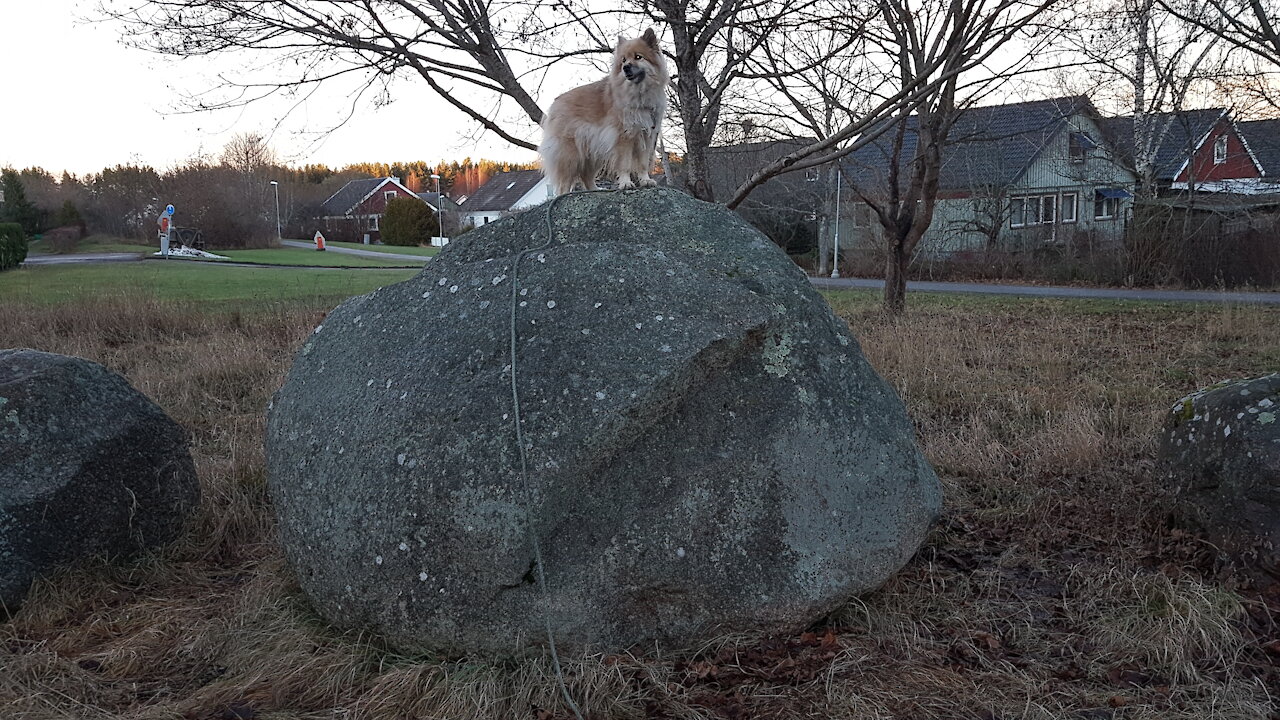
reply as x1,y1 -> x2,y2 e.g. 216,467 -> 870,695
266,190 -> 941,656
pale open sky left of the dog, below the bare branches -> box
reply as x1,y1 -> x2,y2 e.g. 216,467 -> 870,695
0,0 -> 534,176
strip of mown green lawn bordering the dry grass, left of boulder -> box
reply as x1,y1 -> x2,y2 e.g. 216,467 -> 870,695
0,260 -> 417,306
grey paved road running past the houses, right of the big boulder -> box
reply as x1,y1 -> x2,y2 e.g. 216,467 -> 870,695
809,278 -> 1280,305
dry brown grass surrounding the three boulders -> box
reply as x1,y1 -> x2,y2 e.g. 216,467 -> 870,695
0,295 -> 1280,720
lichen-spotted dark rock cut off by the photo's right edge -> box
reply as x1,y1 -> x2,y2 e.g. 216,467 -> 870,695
1160,373 -> 1280,577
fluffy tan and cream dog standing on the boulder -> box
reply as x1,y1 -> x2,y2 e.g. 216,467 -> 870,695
538,28 -> 669,195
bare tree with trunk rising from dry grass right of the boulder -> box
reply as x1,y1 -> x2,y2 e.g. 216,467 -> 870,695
730,0 -> 1055,313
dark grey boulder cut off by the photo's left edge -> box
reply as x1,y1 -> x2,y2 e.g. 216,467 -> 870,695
0,350 -> 200,611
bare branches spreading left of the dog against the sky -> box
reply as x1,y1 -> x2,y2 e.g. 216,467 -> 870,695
100,0 -> 567,150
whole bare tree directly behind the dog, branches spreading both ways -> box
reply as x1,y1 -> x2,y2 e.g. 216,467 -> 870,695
101,0 -> 1056,235
